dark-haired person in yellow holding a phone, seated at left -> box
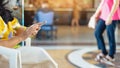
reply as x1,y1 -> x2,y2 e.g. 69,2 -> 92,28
0,0 -> 41,48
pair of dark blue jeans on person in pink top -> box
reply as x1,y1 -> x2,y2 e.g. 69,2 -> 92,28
95,19 -> 117,58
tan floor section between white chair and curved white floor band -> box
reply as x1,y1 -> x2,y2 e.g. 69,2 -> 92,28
47,49 -> 76,68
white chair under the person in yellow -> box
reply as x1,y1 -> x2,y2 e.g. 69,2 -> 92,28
0,38 -> 58,68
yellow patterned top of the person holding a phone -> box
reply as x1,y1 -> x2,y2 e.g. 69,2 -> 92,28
0,16 -> 21,48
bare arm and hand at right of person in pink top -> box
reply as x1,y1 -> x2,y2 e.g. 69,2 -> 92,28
106,0 -> 120,25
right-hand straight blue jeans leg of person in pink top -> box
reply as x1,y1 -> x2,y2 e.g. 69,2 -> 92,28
106,21 -> 117,58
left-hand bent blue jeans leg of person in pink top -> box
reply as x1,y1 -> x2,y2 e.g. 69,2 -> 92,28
95,19 -> 107,55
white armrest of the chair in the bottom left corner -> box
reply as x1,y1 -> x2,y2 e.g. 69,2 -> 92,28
0,46 -> 22,68
